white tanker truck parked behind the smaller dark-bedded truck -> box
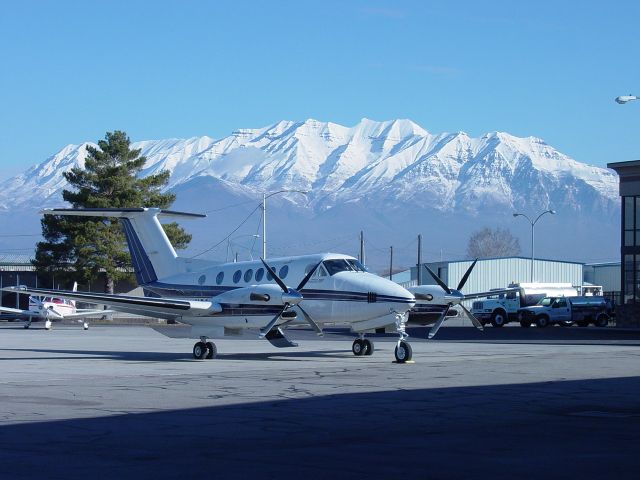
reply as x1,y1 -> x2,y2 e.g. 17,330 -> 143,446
471,283 -> 578,327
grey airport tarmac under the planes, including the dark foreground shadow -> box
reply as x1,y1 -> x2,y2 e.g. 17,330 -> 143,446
0,323 -> 640,480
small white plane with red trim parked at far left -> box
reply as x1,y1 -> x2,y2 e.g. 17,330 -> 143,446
0,282 -> 111,330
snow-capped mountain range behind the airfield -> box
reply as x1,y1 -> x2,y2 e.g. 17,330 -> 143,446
0,119 -> 619,270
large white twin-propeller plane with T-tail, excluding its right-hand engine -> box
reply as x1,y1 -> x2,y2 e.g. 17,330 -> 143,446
5,208 -> 415,363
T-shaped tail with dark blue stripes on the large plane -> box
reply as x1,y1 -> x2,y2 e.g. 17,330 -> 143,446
42,208 -> 206,285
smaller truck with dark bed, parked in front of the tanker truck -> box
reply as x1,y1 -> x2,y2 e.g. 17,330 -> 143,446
518,296 -> 610,328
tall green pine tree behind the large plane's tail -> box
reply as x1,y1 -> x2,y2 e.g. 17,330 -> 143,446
34,131 -> 191,293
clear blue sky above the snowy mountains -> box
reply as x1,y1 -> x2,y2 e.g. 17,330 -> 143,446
0,0 -> 640,178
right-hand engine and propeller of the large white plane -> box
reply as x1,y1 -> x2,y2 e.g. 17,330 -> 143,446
408,258 -> 515,339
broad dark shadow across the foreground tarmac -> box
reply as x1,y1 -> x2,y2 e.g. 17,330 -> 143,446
0,377 -> 640,480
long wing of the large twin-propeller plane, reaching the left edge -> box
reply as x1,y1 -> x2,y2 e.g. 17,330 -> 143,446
2,287 -> 222,319
